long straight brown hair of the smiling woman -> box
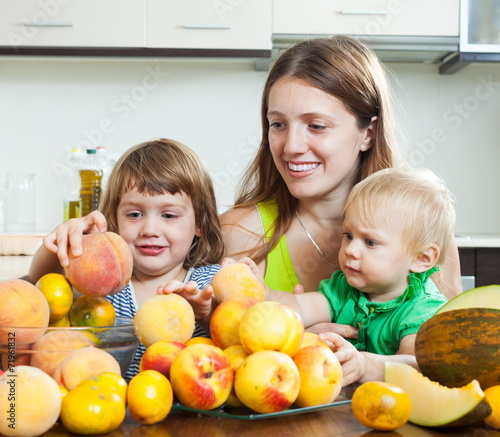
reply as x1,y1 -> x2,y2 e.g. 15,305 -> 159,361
235,36 -> 402,262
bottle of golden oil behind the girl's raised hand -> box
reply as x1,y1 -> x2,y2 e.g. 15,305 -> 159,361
80,149 -> 102,217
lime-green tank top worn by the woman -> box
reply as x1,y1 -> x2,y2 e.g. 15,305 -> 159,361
257,197 -> 299,293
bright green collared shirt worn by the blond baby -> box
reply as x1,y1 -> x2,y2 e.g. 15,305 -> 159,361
318,268 -> 447,355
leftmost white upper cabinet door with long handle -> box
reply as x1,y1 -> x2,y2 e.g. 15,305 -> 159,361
0,0 -> 146,47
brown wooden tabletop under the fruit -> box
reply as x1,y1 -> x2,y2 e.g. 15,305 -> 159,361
44,405 -> 500,437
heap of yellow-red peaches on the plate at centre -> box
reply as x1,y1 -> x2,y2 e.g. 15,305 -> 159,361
134,263 -> 342,413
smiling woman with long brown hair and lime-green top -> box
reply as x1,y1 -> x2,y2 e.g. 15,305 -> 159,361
221,36 -> 461,337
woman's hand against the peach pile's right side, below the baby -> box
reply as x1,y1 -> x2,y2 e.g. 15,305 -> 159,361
320,332 -> 366,387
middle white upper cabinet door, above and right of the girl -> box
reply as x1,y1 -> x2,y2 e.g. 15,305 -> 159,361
147,0 -> 272,50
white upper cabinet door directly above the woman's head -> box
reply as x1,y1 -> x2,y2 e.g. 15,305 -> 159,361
273,0 -> 459,36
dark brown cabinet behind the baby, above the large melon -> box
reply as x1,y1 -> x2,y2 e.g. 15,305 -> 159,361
458,247 -> 500,287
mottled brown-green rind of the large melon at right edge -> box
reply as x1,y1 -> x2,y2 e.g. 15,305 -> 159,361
415,308 -> 500,390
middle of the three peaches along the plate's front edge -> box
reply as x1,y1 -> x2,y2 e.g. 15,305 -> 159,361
234,350 -> 300,413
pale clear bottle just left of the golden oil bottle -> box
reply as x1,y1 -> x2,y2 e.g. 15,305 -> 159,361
63,148 -> 85,221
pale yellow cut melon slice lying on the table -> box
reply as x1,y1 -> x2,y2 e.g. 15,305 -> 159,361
384,362 -> 491,427
